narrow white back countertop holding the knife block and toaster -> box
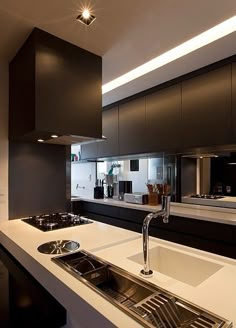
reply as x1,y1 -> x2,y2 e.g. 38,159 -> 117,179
71,197 -> 236,225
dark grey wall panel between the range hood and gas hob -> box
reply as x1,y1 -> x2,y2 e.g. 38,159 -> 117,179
9,141 -> 69,219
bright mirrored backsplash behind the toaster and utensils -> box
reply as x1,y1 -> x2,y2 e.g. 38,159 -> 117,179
97,155 -> 176,205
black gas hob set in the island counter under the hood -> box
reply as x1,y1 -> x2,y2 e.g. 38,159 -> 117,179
22,213 -> 92,231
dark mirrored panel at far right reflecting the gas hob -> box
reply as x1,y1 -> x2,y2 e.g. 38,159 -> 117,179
181,152 -> 236,208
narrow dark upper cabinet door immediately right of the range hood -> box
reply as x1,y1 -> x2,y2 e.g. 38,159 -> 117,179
98,106 -> 119,158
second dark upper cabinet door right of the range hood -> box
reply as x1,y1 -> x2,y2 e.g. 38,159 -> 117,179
119,97 -> 147,155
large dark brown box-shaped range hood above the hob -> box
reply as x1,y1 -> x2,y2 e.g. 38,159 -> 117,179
9,28 -> 102,145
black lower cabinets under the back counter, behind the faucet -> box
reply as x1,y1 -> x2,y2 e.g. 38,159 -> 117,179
73,201 -> 236,259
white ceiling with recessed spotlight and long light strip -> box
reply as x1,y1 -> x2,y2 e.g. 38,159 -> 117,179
0,0 -> 236,105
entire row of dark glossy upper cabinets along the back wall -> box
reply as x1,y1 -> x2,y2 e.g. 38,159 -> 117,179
79,59 -> 236,158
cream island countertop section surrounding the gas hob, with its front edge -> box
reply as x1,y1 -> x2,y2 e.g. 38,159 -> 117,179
0,220 -> 140,328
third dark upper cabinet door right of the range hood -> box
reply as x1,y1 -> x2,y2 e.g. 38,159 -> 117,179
146,84 -> 182,152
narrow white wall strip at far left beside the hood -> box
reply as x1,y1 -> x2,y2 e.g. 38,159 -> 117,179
0,60 -> 8,221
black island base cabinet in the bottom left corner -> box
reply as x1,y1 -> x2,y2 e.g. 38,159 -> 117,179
0,245 -> 66,328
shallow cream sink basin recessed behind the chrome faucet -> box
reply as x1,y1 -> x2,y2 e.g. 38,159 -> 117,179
128,246 -> 222,287
